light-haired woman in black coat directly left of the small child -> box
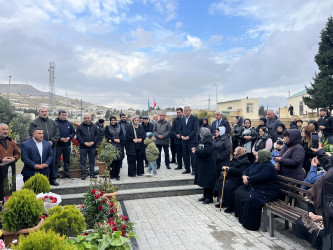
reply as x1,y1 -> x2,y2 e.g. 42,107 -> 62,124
125,116 -> 146,177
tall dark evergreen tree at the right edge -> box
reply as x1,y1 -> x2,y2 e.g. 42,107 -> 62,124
303,17 -> 333,110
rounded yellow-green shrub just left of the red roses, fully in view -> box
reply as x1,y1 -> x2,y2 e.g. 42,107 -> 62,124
42,205 -> 86,237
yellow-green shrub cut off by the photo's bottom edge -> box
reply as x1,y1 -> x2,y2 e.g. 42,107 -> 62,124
12,230 -> 77,250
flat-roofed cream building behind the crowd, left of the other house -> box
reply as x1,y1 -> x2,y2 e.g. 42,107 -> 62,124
217,98 -> 259,119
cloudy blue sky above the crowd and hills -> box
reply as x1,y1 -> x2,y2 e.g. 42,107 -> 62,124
0,0 -> 333,109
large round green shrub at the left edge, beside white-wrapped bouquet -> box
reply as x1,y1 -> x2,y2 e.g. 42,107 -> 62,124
1,189 -> 44,232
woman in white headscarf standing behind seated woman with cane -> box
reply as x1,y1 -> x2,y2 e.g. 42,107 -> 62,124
213,126 -> 231,178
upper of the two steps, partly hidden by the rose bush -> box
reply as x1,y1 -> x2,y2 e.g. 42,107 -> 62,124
51,177 -> 194,195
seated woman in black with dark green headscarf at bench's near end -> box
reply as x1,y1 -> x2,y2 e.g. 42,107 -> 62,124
235,150 -> 280,231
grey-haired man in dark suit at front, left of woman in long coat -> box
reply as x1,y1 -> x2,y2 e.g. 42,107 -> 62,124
177,106 -> 199,175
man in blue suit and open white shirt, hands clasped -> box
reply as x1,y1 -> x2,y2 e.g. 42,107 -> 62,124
21,127 -> 54,182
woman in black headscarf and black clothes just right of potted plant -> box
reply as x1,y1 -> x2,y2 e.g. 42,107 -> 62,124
104,116 -> 124,181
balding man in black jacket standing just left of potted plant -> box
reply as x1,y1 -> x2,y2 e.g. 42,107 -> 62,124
76,114 -> 98,180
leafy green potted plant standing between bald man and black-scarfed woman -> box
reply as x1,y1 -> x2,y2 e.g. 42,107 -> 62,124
96,140 -> 119,175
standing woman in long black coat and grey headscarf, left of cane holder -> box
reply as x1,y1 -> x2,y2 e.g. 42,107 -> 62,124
192,127 -> 216,204
